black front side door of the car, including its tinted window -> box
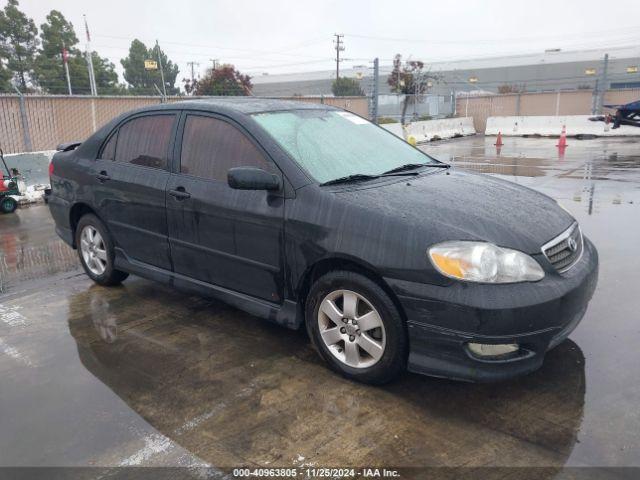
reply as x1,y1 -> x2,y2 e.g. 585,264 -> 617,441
167,114 -> 284,303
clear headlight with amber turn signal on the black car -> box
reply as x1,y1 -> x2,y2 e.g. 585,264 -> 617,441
429,241 -> 544,283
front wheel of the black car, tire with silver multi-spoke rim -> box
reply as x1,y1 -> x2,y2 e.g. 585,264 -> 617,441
305,271 -> 409,384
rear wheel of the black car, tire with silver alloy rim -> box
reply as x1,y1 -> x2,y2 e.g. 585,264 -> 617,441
76,214 -> 129,286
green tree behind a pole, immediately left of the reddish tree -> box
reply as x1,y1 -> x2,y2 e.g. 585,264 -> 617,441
120,39 -> 179,95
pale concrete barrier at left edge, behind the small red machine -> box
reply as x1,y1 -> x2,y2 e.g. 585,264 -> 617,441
2,150 -> 56,204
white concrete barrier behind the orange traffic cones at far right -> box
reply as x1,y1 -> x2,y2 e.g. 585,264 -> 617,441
484,115 -> 640,137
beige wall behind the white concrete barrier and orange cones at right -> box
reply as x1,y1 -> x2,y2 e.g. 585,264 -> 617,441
456,89 -> 640,132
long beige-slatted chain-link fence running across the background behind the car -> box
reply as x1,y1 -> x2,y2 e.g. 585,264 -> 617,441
0,89 -> 640,153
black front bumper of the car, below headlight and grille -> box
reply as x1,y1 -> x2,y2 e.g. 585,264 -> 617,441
387,237 -> 598,382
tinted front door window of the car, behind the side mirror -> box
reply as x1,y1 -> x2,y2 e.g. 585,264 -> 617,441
180,115 -> 274,182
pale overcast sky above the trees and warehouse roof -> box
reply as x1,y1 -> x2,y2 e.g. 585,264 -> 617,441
13,0 -> 640,79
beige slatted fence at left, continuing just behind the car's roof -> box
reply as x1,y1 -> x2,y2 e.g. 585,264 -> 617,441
0,95 -> 368,153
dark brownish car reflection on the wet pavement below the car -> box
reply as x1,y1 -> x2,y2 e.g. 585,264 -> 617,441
69,280 -> 585,477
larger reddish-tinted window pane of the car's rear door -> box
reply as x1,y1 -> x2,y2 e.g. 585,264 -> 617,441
115,115 -> 175,169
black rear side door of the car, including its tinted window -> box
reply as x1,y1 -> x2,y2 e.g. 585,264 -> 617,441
94,112 -> 178,270
